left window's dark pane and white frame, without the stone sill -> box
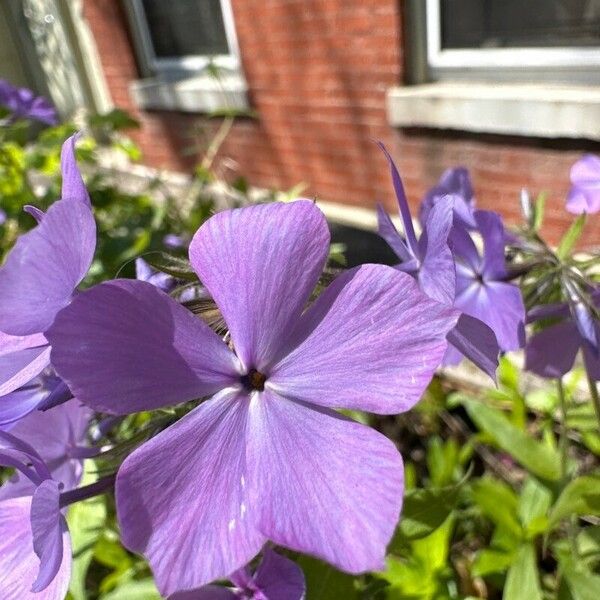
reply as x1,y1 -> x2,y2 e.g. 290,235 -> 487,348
130,0 -> 239,77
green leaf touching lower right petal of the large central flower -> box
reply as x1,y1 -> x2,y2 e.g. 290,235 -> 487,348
390,484 -> 460,550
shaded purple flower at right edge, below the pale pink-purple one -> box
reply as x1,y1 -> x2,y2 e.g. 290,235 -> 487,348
525,290 -> 600,381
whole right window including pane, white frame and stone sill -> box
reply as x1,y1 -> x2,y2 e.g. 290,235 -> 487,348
387,0 -> 600,140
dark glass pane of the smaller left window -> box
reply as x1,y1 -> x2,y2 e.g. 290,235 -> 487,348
142,0 -> 229,58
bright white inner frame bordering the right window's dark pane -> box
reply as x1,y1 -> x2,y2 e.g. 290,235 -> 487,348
426,0 -> 600,69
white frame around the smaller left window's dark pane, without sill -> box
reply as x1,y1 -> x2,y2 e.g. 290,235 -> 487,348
130,0 -> 240,73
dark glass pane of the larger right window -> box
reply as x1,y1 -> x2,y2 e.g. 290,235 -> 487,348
440,0 -> 600,49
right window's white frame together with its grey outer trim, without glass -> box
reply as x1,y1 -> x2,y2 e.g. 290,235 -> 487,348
420,0 -> 600,81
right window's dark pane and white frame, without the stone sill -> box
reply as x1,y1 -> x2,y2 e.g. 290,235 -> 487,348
409,0 -> 600,84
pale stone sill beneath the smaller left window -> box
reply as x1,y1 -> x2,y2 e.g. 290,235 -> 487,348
130,74 -> 249,113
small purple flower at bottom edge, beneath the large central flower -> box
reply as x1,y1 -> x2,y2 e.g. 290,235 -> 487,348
169,546 -> 306,600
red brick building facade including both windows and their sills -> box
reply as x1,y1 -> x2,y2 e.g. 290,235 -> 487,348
1,0 -> 600,245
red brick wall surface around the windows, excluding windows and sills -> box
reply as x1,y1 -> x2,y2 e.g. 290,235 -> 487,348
85,0 -> 600,243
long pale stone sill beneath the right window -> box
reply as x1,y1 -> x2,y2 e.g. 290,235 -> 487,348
387,82 -> 600,140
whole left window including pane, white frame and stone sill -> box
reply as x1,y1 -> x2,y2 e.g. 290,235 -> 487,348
123,0 -> 248,112
